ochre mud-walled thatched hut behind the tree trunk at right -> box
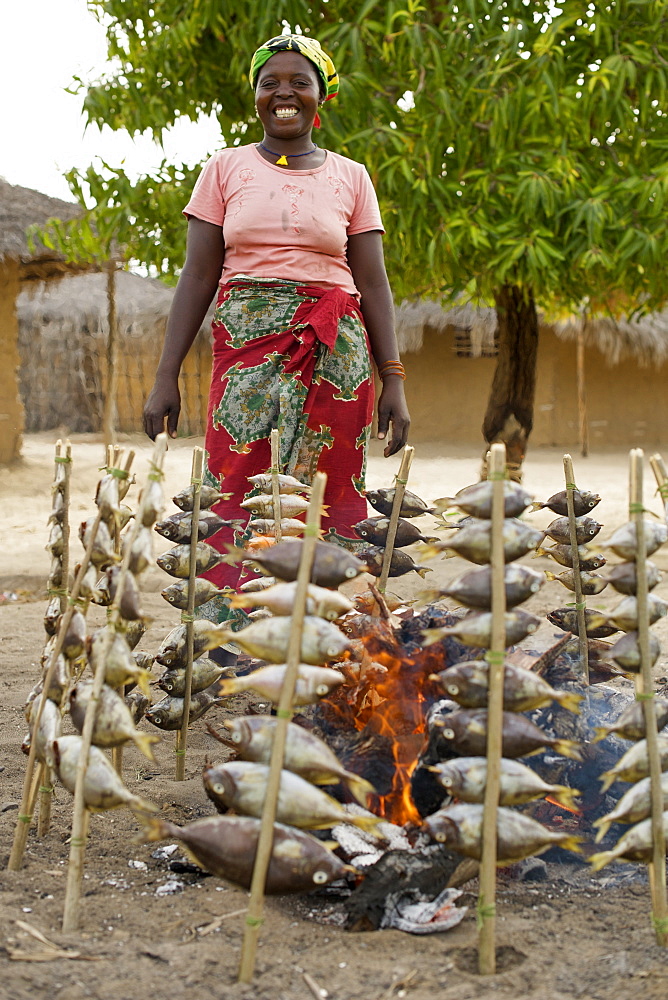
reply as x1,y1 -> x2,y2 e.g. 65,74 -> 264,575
397,301 -> 668,448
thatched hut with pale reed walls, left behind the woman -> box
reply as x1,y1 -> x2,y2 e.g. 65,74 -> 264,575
17,271 -> 211,434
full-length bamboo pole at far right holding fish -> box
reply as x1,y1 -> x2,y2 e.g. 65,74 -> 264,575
629,448 -> 668,948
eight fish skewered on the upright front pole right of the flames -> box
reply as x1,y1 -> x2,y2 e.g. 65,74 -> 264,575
396,482 -> 580,864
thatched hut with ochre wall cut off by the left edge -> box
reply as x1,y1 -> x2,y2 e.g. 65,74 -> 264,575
0,179 -> 86,463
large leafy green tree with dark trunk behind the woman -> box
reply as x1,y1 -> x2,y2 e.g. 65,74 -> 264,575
49,0 -> 668,468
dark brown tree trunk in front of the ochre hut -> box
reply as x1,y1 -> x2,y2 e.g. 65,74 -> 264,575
482,285 -> 538,482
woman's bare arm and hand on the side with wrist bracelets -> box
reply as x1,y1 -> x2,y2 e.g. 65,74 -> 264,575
348,231 -> 411,458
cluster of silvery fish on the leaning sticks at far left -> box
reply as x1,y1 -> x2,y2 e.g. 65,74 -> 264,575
23,460 -> 177,810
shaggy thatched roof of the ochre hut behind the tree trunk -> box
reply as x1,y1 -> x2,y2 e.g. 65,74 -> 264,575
396,299 -> 668,366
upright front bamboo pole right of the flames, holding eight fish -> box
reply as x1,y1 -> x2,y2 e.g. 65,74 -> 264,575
478,444 -> 506,976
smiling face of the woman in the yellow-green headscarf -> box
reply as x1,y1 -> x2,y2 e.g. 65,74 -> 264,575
255,51 -> 321,139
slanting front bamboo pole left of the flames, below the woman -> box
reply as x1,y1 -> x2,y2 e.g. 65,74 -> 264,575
239,472 -> 327,983
